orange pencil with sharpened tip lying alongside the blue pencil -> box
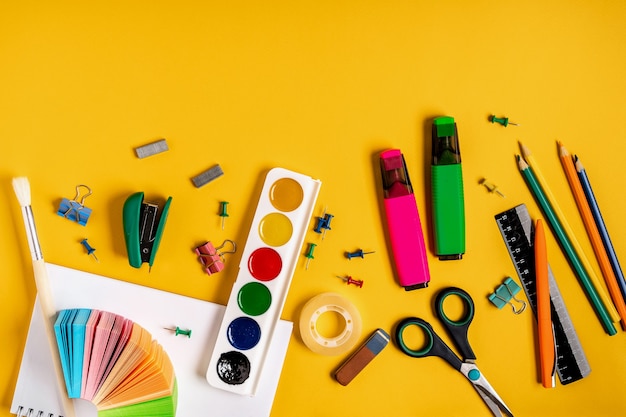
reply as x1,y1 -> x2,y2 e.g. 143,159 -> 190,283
558,142 -> 626,330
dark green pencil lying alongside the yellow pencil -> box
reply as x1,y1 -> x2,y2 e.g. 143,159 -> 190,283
517,155 -> 617,336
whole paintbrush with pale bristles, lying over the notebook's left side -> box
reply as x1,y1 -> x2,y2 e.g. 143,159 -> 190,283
13,177 -> 75,417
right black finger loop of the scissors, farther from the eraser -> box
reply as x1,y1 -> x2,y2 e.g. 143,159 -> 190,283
435,287 -> 476,360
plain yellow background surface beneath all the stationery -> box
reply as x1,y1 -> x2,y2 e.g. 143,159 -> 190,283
0,0 -> 626,417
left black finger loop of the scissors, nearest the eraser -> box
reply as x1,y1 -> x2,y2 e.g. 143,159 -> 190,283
395,317 -> 462,369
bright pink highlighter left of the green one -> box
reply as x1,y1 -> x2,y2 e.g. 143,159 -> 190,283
380,149 -> 430,291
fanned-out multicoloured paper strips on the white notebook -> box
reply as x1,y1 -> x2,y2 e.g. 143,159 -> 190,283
54,308 -> 178,417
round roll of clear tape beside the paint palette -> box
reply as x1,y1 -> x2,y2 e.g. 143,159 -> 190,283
300,293 -> 362,355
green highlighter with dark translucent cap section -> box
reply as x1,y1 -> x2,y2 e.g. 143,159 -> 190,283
431,116 -> 465,261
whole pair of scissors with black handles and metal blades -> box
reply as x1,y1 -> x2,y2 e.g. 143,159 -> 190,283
395,287 -> 513,417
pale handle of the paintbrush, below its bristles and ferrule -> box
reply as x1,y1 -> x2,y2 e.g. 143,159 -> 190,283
33,259 -> 76,417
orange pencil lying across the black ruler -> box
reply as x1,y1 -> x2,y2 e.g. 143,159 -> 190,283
534,219 -> 556,388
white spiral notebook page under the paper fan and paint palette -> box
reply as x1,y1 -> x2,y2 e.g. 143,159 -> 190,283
11,264 -> 293,417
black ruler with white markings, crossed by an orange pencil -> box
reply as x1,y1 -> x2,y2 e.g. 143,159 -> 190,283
495,204 -> 591,385
